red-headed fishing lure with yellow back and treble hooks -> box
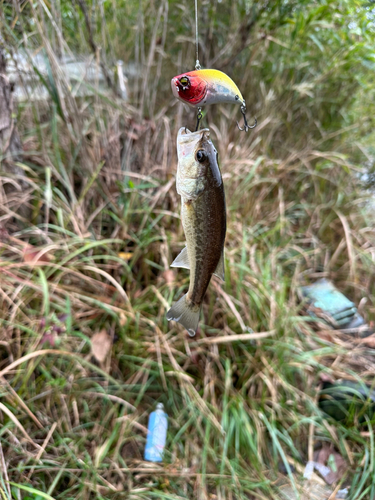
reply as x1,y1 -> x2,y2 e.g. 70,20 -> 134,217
171,69 -> 257,132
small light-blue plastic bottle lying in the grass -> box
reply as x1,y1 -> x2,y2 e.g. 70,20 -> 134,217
145,403 -> 168,462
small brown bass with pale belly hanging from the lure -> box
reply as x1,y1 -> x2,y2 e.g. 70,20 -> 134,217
167,127 -> 226,337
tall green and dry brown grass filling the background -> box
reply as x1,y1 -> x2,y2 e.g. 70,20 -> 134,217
0,0 -> 375,500
